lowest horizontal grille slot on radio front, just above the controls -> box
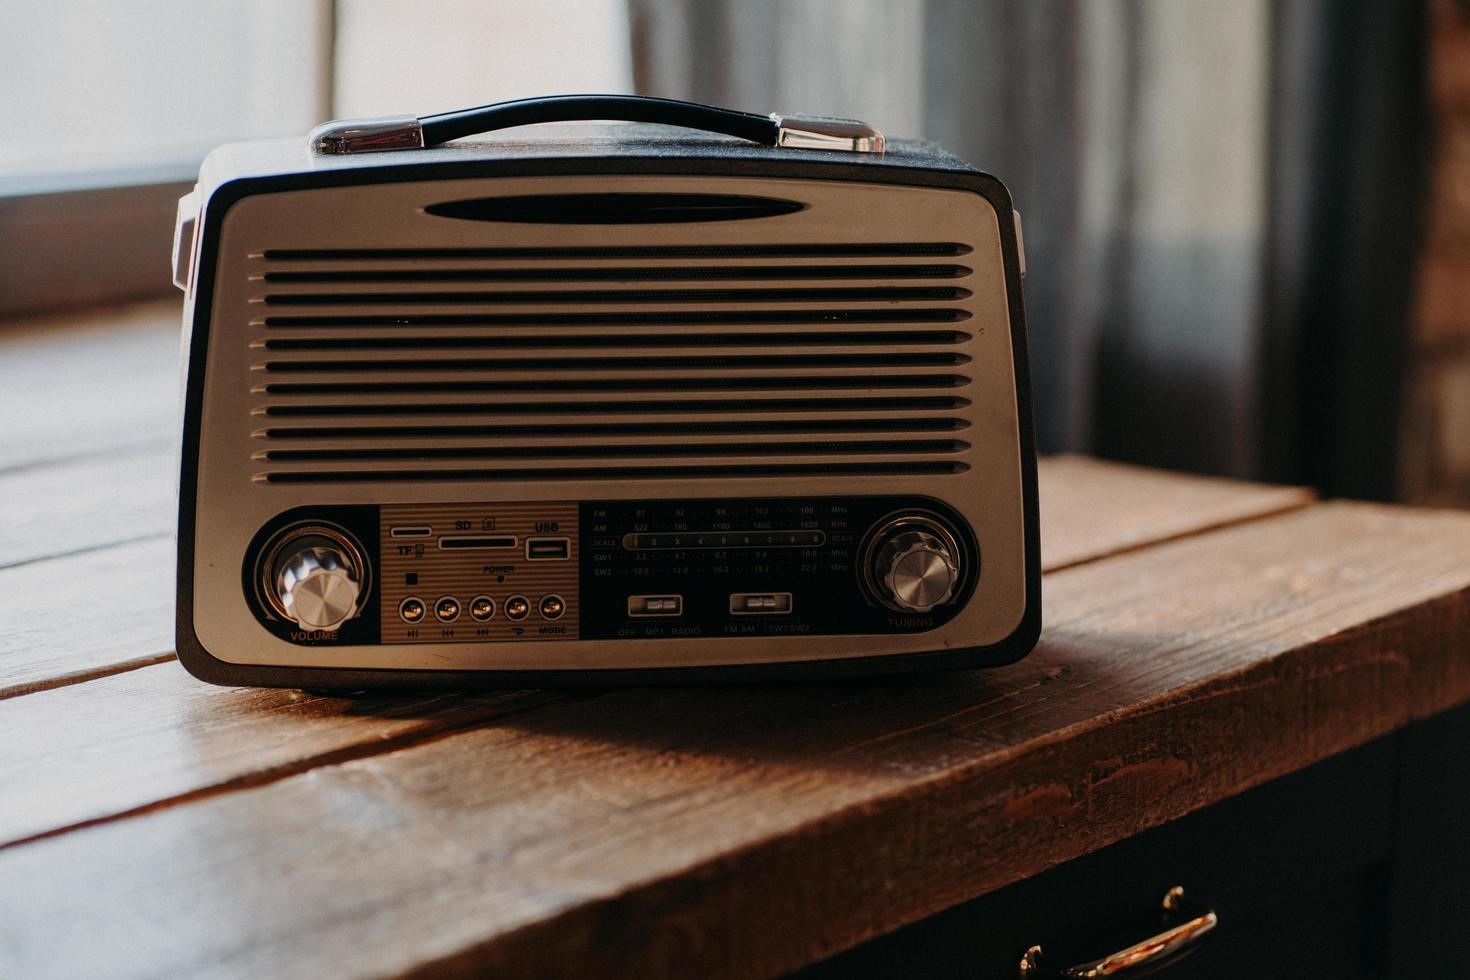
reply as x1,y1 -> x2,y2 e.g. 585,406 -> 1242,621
260,460 -> 970,483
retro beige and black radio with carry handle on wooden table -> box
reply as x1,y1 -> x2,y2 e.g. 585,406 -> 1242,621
175,96 -> 1041,689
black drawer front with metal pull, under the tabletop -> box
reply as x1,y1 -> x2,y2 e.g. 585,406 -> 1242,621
801,739 -> 1395,977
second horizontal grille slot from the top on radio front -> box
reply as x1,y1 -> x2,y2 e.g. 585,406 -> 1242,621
265,264 -> 970,282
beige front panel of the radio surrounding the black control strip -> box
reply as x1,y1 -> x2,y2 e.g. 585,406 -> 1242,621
194,176 -> 1025,670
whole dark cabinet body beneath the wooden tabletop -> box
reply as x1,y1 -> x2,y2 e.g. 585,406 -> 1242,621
798,708 -> 1470,980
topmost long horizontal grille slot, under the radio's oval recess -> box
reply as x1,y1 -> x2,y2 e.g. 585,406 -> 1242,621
263,241 -> 970,262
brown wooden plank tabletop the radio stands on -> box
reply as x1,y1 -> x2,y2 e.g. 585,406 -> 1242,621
0,306 -> 1470,977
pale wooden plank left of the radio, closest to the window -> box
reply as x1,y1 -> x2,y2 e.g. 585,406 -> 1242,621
0,300 -> 179,473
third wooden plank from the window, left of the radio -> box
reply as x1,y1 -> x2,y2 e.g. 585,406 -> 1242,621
0,536 -> 173,696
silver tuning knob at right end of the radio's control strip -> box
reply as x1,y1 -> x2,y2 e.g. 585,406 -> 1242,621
867,516 -> 961,613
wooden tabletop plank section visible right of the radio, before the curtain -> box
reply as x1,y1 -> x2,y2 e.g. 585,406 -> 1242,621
1038,455 -> 1313,572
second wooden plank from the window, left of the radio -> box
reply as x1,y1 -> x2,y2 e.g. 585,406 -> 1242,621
0,447 -> 178,567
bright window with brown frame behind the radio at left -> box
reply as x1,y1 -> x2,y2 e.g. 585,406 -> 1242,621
0,0 -> 632,314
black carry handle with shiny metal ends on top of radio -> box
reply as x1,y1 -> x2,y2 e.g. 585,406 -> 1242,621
307,96 -> 883,154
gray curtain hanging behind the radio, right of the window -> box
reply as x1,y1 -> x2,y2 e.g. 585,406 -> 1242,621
631,0 -> 1423,495
